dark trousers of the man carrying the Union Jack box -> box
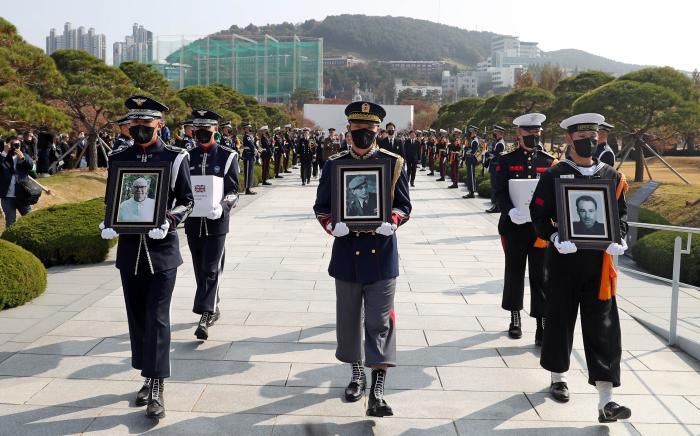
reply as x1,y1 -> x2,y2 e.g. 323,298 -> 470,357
187,233 -> 226,315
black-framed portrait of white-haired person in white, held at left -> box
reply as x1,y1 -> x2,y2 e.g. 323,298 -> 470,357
104,162 -> 170,234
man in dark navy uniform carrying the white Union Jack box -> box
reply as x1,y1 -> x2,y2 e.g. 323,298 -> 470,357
185,109 -> 240,340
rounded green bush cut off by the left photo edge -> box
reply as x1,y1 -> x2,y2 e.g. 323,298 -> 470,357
0,240 -> 46,309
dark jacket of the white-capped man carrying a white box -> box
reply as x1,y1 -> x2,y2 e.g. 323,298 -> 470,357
493,147 -> 556,235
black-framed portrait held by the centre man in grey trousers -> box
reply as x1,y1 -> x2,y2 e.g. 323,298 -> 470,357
331,159 -> 392,232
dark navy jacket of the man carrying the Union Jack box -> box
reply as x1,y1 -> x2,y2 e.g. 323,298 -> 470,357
185,144 -> 240,237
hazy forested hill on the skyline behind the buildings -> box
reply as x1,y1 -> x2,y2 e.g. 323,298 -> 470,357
213,14 -> 642,75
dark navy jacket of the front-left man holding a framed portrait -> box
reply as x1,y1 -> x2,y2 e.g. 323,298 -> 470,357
109,138 -> 194,274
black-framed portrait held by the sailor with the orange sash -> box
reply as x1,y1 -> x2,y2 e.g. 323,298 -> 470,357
554,178 -> 621,250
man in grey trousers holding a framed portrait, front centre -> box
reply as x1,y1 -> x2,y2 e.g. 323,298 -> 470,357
314,101 -> 411,417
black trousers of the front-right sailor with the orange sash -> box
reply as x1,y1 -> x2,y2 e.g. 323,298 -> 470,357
540,247 -> 622,387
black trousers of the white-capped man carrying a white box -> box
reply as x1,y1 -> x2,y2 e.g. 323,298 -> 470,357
501,223 -> 547,318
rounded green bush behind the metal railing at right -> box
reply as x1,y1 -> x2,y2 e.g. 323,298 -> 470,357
632,230 -> 700,286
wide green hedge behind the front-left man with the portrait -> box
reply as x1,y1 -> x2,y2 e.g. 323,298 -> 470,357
2,198 -> 116,267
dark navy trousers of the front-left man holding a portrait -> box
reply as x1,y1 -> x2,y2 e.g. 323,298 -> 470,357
120,262 -> 177,378
